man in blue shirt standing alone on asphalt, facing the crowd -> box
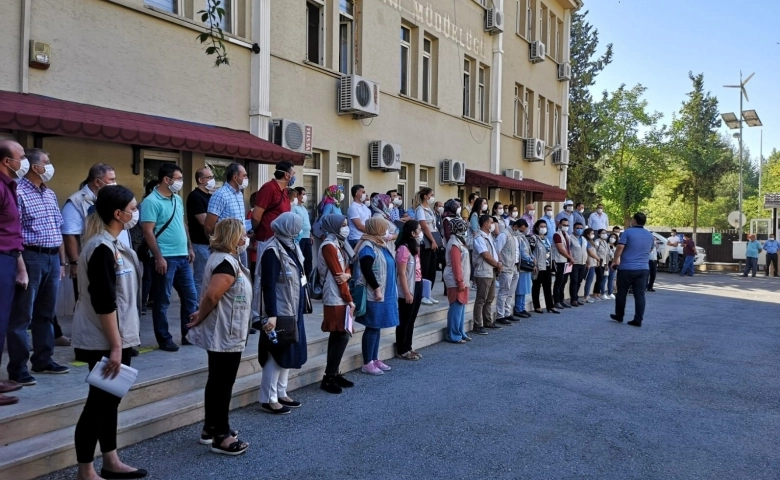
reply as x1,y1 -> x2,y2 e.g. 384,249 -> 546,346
610,212 -> 655,327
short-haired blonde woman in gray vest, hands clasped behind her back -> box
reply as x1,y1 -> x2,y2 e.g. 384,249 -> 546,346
187,218 -> 252,456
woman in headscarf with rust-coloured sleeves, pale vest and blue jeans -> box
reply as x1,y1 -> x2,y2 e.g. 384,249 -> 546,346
443,216 -> 471,343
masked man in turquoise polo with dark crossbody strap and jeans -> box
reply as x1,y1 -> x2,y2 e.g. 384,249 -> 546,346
141,163 -> 200,352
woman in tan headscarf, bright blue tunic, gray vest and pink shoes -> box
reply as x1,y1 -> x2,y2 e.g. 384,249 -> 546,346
355,217 -> 398,375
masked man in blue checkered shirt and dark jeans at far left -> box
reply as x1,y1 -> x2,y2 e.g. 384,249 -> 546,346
7,148 -> 70,386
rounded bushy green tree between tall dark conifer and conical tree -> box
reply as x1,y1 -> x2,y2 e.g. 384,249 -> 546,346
596,85 -> 667,225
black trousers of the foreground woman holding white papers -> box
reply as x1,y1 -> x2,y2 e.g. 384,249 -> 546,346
74,348 -> 130,463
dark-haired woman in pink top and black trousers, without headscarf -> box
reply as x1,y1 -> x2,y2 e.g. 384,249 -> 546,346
395,220 -> 422,360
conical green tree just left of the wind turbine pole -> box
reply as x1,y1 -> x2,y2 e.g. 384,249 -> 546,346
672,72 -> 735,235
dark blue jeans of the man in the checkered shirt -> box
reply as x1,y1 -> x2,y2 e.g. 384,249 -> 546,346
7,250 -> 60,380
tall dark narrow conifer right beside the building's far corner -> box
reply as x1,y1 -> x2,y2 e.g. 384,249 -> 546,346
567,11 -> 612,205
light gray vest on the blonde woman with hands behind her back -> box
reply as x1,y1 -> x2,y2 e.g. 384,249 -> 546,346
187,252 -> 252,352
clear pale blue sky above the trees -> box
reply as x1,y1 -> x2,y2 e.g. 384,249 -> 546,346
583,0 -> 780,164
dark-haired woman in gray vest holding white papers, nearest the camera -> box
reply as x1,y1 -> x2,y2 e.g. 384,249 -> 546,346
73,185 -> 147,478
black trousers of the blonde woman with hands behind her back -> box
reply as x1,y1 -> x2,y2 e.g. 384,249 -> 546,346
203,351 -> 241,435
